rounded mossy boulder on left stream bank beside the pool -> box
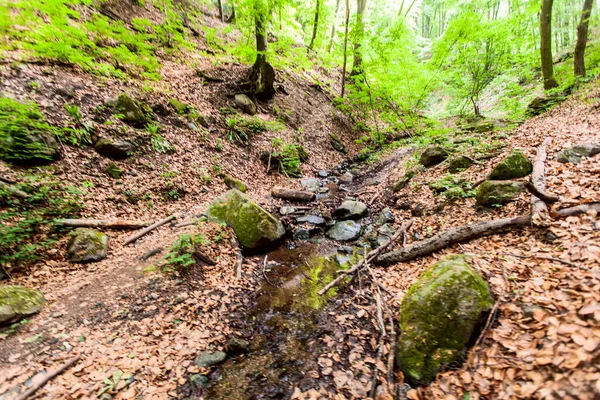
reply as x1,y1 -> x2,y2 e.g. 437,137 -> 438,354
207,189 -> 285,249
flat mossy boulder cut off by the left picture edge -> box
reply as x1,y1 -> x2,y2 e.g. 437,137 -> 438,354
0,286 -> 46,326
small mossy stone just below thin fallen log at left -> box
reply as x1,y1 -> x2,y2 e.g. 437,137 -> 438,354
67,228 -> 108,263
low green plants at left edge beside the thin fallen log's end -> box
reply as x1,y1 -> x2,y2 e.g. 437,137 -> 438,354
0,175 -> 81,271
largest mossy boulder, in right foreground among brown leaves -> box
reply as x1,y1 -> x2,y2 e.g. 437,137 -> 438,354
396,256 -> 494,384
